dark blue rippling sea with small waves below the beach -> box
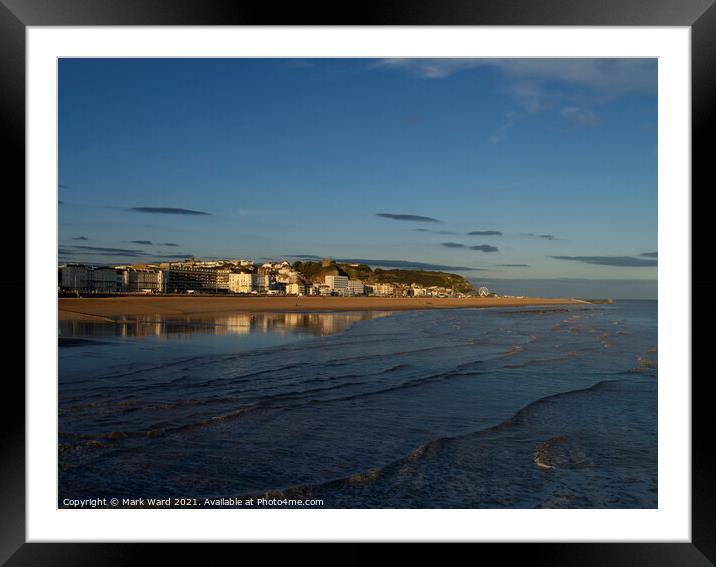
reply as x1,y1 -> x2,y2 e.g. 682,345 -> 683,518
58,301 -> 658,508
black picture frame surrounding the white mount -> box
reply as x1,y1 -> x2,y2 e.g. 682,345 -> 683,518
0,0 -> 716,567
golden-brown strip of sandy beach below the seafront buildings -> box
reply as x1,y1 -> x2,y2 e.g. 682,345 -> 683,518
58,296 -> 591,322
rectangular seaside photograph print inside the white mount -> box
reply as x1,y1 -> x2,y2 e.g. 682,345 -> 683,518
57,58 -> 659,509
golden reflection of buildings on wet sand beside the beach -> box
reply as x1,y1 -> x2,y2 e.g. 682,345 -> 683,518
58,311 -> 391,338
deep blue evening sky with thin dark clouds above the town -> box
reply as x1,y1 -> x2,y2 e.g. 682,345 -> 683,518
58,59 -> 657,295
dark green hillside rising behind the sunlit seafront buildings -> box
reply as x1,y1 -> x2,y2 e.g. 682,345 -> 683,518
293,260 -> 474,293
